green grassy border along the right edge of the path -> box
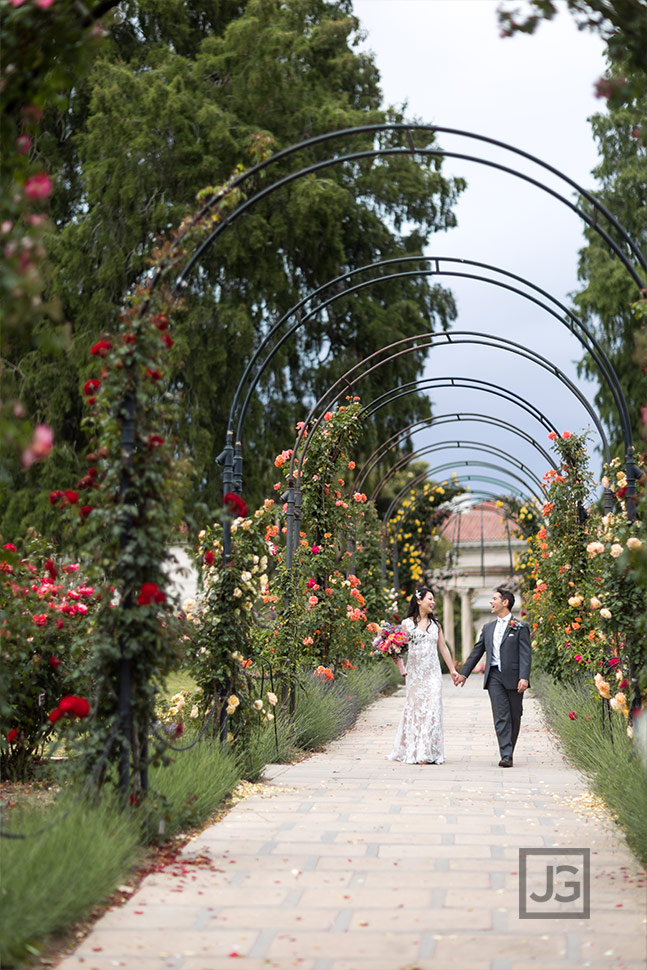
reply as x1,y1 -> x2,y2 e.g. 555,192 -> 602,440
532,674 -> 647,863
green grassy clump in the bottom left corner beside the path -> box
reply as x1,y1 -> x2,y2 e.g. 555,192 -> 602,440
0,791 -> 141,967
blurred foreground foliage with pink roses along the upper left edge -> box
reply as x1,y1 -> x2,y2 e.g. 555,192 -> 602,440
0,0 -> 117,484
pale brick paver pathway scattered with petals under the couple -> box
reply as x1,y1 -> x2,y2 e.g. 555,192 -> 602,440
59,676 -> 646,970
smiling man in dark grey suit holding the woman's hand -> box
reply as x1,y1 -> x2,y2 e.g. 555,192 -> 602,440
455,586 -> 530,768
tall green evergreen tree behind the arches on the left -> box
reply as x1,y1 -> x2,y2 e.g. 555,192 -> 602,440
0,0 -> 463,534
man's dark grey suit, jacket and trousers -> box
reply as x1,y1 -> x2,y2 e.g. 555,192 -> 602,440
461,617 -> 531,758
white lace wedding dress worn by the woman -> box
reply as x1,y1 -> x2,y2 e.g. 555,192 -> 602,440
388,617 -> 445,765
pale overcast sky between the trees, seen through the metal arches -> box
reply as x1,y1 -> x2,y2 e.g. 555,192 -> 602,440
354,0 -> 605,500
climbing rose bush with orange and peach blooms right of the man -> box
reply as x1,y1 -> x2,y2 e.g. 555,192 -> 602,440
520,432 -> 647,696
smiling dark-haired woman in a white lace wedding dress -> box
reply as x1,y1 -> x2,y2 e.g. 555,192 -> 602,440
388,586 -> 459,765
